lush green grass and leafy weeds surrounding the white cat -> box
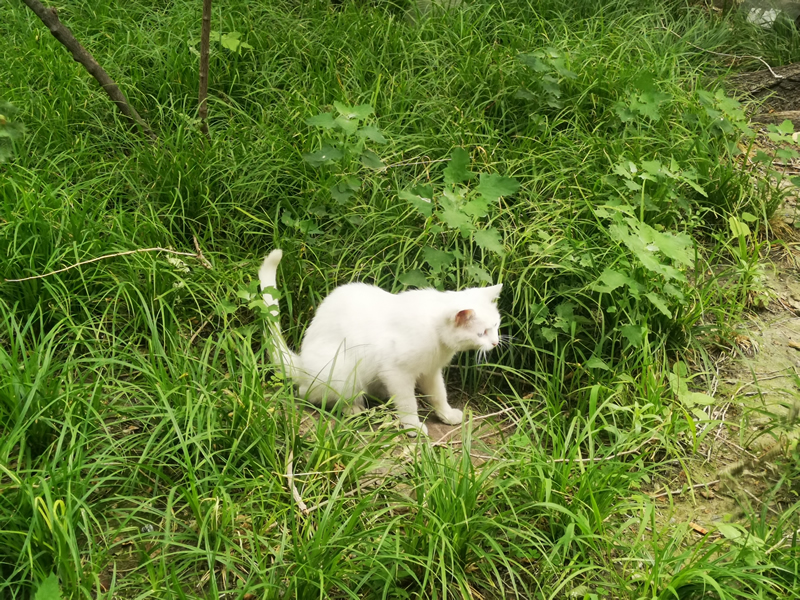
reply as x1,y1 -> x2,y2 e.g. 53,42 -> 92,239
0,0 -> 800,600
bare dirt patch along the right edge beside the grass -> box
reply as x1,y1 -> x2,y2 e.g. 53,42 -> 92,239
651,243 -> 800,535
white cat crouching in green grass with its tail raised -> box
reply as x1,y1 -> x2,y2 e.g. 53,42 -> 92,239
258,250 -> 503,436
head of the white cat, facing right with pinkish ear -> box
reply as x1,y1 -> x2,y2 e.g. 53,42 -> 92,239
450,283 -> 503,352
